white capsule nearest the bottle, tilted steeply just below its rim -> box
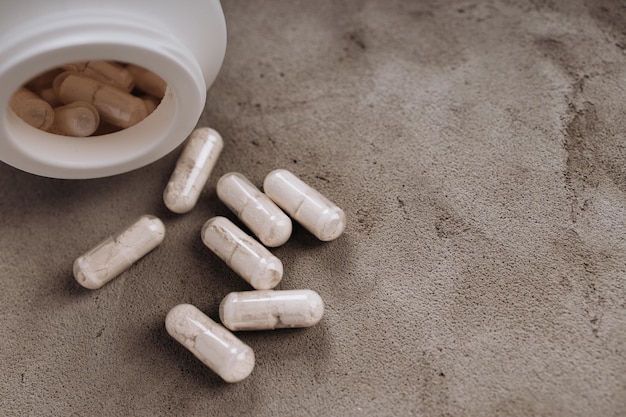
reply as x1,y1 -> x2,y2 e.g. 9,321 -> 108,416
163,127 -> 224,214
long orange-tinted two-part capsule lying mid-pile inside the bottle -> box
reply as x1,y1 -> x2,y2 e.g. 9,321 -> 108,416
52,71 -> 148,129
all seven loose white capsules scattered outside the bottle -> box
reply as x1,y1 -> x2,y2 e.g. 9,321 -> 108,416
74,128 -> 346,382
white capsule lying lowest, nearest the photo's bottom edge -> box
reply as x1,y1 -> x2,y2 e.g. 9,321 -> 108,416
165,304 -> 254,382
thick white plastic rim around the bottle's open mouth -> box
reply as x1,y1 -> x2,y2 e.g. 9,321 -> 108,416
0,13 -> 207,178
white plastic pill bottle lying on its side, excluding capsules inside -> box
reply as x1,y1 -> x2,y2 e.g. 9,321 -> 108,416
0,0 -> 226,178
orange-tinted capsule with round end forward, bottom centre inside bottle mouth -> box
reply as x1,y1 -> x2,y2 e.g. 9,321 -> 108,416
53,101 -> 100,137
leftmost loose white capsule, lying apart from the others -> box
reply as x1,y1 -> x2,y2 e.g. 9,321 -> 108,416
74,215 -> 165,290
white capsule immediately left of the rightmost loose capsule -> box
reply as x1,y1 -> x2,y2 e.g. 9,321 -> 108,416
217,172 -> 291,247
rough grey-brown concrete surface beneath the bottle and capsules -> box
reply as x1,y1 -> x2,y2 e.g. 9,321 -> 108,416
0,0 -> 626,416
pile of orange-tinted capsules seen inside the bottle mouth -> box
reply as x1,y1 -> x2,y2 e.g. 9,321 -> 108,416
9,60 -> 167,137
